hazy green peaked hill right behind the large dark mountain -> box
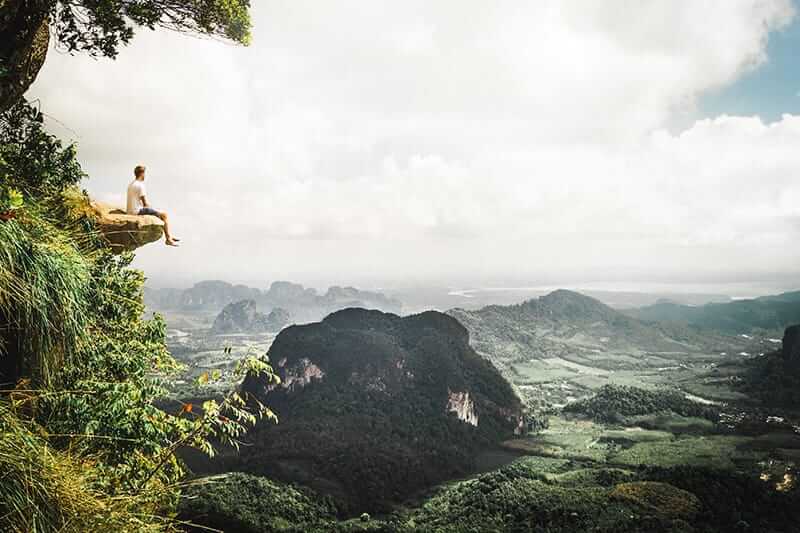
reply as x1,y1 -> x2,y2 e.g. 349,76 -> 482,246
448,290 -> 732,388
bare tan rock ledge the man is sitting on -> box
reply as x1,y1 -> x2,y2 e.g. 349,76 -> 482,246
91,201 -> 164,253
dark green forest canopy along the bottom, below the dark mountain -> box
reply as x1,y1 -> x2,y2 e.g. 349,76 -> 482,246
178,457 -> 800,533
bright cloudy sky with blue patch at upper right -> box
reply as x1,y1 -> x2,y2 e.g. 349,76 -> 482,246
29,0 -> 800,288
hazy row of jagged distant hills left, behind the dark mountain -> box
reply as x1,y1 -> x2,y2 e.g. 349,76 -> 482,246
144,280 -> 402,322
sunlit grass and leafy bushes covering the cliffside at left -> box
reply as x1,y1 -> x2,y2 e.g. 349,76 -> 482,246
0,91 -> 272,531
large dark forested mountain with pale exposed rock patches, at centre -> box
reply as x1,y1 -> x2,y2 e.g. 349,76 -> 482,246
189,309 -> 524,513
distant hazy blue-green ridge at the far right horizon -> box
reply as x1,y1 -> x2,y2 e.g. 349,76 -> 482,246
624,291 -> 800,334
